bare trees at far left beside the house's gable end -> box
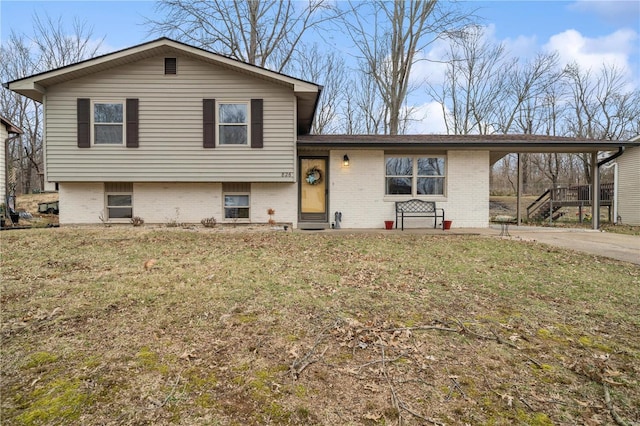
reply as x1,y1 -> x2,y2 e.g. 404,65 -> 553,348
0,14 -> 102,193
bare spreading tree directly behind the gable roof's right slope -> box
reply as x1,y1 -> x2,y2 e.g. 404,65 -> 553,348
146,0 -> 333,72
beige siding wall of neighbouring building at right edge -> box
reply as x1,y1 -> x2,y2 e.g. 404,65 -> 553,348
617,147 -> 640,225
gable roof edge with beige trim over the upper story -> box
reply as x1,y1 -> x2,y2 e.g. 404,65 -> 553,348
4,37 -> 322,134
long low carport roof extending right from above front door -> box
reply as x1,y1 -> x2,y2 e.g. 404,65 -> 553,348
298,134 -> 640,163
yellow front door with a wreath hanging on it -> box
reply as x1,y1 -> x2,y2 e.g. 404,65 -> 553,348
298,157 -> 329,223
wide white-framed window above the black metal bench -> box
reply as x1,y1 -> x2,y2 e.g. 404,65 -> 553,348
385,156 -> 446,197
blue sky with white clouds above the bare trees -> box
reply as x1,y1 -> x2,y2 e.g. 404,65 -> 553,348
0,0 -> 640,130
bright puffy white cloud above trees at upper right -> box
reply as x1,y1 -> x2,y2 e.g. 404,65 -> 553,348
543,29 -> 638,73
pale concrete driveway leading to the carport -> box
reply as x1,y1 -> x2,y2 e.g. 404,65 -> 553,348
500,226 -> 640,265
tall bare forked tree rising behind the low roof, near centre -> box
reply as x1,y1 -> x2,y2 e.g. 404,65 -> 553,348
342,0 -> 468,135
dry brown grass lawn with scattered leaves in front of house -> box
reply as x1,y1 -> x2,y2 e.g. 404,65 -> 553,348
0,227 -> 640,425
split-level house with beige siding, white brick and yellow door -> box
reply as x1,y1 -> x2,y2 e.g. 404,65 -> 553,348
6,38 -> 640,229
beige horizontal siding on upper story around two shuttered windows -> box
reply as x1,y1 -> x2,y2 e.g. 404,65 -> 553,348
46,55 -> 296,182
